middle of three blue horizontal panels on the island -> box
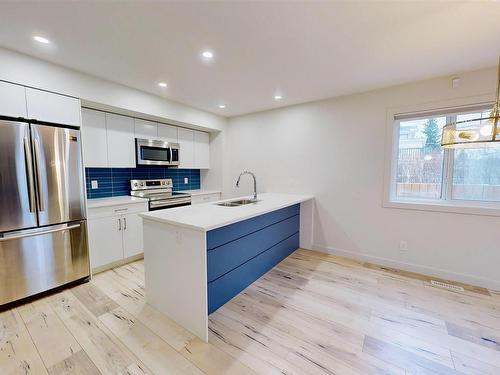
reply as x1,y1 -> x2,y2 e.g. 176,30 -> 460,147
207,215 -> 300,282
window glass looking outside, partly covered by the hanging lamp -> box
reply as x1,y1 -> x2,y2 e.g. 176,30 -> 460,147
391,106 -> 500,209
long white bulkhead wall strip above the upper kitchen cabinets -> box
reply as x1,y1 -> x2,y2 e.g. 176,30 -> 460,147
0,48 -> 227,131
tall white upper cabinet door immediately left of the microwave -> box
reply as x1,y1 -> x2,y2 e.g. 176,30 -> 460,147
106,113 -> 135,168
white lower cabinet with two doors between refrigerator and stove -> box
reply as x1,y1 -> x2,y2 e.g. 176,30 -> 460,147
88,203 -> 148,272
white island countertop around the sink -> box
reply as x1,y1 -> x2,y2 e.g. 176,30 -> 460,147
139,193 -> 314,231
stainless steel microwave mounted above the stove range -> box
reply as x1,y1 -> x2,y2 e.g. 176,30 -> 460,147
135,138 -> 180,167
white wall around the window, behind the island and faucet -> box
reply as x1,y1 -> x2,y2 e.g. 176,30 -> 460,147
223,69 -> 500,289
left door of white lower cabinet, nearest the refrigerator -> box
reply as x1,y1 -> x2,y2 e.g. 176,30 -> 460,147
88,216 -> 123,269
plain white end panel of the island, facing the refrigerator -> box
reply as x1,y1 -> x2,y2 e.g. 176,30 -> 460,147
144,218 -> 208,342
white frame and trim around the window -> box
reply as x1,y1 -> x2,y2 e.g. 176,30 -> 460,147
383,96 -> 500,216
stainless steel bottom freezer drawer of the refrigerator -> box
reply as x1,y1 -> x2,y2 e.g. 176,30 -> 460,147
0,220 -> 90,305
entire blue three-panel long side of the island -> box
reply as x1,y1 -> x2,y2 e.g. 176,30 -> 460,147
207,204 -> 300,314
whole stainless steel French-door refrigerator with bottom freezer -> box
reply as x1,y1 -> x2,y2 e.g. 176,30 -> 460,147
0,120 -> 90,306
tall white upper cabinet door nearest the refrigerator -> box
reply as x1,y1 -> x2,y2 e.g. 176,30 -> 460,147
82,108 -> 108,167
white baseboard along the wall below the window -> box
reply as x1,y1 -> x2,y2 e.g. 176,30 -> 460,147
312,245 -> 500,290
